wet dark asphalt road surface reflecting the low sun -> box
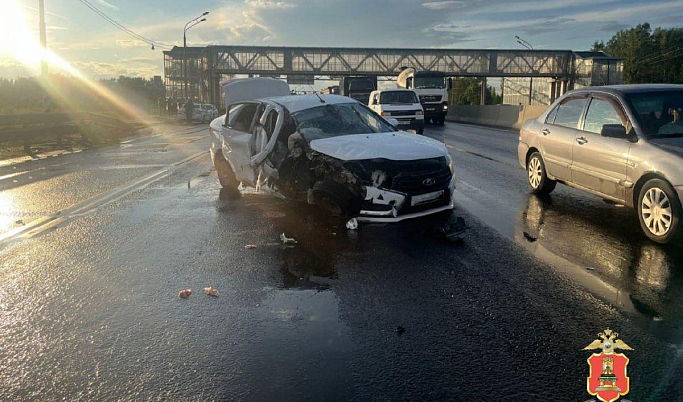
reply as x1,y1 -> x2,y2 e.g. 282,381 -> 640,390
0,123 -> 683,401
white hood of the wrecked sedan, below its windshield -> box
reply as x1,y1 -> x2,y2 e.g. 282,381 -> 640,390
310,131 -> 448,161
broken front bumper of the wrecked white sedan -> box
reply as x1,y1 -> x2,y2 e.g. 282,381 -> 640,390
356,175 -> 455,223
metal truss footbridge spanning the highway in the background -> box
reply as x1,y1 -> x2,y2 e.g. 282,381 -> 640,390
164,46 -> 616,104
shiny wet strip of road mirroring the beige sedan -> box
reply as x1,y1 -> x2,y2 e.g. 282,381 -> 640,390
456,189 -> 683,343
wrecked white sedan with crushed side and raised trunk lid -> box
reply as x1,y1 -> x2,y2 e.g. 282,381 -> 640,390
210,78 -> 455,222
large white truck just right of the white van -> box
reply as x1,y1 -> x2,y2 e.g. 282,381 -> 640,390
396,67 -> 450,125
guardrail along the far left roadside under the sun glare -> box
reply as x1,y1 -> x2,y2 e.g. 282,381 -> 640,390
0,112 -> 134,157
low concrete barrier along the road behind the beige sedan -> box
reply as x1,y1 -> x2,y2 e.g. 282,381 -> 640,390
446,105 -> 547,128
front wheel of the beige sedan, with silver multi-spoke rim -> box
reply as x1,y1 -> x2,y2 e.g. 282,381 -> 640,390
637,179 -> 683,244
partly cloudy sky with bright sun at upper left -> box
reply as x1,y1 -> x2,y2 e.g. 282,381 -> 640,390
0,0 -> 683,78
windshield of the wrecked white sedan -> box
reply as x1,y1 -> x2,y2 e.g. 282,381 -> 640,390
292,103 -> 396,139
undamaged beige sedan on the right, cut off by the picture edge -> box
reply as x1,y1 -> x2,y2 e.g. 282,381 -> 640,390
518,84 -> 683,243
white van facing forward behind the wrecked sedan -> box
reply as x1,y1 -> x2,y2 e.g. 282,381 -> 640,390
369,88 -> 424,134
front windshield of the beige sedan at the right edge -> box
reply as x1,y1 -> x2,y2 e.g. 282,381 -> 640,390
625,91 -> 683,137
